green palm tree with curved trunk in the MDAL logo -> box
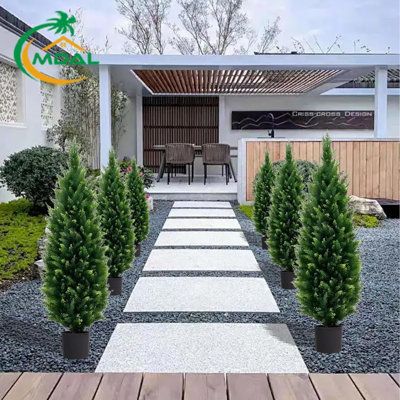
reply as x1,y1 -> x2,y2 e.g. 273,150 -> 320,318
14,11 -> 76,78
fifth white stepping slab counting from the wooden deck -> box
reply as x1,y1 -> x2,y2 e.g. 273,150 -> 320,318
163,218 -> 242,231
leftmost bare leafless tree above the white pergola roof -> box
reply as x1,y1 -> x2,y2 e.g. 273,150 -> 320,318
116,0 -> 171,54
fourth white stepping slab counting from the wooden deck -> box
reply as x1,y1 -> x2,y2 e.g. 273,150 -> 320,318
154,231 -> 249,247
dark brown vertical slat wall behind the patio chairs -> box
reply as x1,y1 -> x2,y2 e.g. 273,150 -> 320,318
143,97 -> 219,170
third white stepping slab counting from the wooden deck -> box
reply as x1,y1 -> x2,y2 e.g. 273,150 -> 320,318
143,249 -> 260,271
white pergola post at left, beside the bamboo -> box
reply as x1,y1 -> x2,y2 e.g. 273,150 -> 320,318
99,65 -> 112,168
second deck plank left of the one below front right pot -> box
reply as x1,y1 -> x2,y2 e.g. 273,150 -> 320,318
226,374 -> 273,400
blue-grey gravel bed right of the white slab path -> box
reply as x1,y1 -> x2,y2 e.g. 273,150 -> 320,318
235,205 -> 400,373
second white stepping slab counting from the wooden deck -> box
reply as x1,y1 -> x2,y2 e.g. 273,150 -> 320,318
124,276 -> 279,312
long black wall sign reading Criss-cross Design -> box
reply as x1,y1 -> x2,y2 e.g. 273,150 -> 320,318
232,110 -> 374,130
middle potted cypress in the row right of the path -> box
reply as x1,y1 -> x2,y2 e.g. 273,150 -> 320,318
267,145 -> 303,289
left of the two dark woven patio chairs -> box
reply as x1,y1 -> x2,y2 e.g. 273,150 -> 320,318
165,143 -> 195,185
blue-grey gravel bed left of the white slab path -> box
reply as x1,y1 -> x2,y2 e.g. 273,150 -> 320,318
0,201 -> 173,372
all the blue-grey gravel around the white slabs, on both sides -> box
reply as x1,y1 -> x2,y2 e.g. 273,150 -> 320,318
0,201 -> 400,372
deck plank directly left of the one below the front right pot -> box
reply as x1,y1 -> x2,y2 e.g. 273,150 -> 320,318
268,374 -> 318,400
